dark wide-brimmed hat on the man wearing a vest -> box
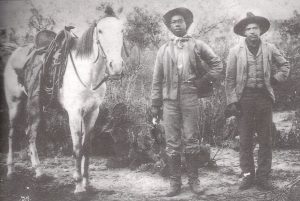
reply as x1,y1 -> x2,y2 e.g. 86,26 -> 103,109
233,12 -> 270,36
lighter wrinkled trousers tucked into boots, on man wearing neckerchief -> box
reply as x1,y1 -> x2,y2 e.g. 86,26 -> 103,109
163,85 -> 200,156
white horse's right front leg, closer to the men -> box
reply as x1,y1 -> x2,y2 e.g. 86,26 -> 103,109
81,107 -> 99,188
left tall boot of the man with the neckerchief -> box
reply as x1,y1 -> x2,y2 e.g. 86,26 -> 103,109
166,155 -> 181,197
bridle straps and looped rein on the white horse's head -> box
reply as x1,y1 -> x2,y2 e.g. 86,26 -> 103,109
69,23 -> 124,91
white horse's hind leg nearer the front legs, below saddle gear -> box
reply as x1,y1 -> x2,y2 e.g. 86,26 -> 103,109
26,97 -> 43,178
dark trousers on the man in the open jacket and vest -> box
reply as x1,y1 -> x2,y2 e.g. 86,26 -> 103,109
238,88 -> 273,177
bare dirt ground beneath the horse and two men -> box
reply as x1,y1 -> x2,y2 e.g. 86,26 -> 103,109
0,148 -> 300,201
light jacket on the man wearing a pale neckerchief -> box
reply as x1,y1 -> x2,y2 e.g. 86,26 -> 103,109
151,38 -> 223,106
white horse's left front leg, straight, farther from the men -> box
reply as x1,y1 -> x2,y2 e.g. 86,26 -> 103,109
69,112 -> 85,193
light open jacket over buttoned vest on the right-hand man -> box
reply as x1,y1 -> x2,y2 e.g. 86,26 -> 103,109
225,41 -> 290,105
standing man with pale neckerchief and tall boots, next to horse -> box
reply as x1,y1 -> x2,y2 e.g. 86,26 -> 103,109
151,8 -> 223,197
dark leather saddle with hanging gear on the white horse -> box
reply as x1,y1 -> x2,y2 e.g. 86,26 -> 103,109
20,27 -> 74,106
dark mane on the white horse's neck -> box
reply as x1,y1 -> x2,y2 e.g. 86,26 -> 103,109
76,25 -> 95,57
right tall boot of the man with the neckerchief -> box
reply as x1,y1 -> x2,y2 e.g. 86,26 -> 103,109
185,154 -> 204,195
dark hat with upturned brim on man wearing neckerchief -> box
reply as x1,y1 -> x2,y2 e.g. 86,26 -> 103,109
163,7 -> 193,30
